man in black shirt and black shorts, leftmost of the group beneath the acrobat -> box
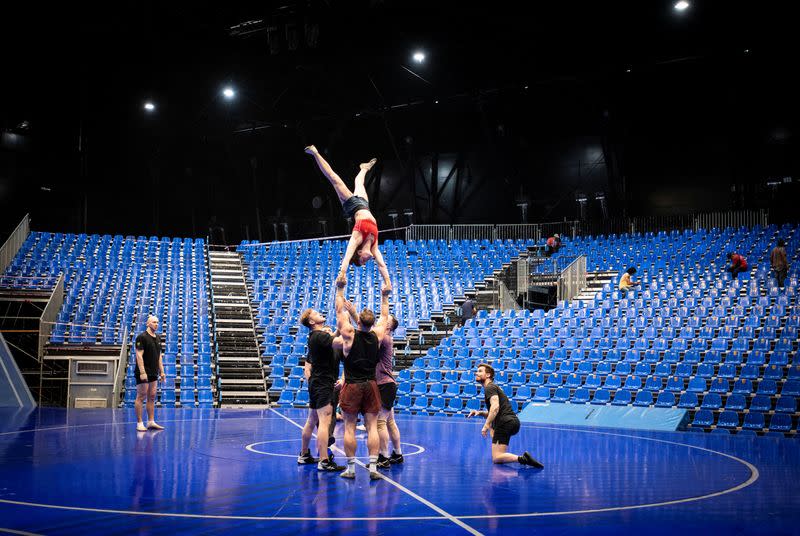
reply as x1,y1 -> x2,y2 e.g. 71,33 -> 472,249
297,309 -> 344,471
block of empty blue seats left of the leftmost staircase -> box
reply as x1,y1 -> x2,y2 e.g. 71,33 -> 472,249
0,232 -> 214,407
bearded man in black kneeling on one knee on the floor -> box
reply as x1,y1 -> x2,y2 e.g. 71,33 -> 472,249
467,363 -> 544,469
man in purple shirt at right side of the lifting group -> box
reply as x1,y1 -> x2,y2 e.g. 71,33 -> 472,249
375,315 -> 403,469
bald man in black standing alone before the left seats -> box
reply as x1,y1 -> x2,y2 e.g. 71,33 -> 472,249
133,316 -> 165,432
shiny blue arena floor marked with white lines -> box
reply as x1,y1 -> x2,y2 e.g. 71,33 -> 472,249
0,409 -> 800,536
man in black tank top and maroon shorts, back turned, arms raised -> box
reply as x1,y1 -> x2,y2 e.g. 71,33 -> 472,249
333,275 -> 391,480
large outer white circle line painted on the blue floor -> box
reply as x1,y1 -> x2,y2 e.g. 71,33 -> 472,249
0,408 -> 760,521
